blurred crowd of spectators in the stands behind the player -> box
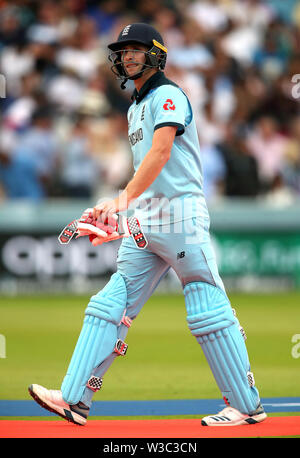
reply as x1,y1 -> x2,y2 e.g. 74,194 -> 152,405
0,0 -> 300,204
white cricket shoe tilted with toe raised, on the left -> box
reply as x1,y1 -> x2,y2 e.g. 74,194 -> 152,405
28,384 -> 89,425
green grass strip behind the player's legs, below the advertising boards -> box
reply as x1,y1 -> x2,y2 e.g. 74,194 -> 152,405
0,293 -> 300,400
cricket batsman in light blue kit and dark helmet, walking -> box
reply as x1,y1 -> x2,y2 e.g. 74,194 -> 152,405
29,23 -> 266,426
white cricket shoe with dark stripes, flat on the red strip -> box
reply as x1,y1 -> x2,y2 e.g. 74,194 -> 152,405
201,405 -> 267,426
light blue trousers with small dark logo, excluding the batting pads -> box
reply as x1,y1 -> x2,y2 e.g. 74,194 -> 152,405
81,218 -> 234,406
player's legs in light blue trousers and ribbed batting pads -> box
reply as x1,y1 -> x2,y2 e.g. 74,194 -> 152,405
62,218 -> 260,414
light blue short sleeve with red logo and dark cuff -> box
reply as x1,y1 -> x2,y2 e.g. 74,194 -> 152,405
152,85 -> 190,136
